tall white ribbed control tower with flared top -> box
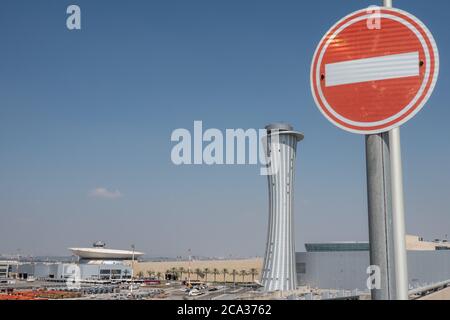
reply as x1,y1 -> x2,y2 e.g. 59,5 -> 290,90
261,123 -> 303,291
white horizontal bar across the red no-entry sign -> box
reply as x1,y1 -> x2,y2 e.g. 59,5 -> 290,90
325,52 -> 420,87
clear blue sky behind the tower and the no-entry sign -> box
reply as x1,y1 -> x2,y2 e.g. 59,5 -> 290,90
0,0 -> 450,256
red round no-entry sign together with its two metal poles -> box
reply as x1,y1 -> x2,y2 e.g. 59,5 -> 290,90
310,0 -> 439,300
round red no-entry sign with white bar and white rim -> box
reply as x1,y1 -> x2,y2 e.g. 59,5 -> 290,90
311,7 -> 439,134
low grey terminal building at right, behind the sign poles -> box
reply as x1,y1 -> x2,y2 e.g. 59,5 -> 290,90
296,236 -> 450,291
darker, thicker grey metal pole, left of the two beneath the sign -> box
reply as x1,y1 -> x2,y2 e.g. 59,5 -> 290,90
366,133 -> 395,300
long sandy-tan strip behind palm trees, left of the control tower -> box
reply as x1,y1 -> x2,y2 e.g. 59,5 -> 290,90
134,258 -> 263,282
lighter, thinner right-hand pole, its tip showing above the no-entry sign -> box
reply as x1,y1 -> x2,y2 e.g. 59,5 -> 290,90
383,0 -> 409,300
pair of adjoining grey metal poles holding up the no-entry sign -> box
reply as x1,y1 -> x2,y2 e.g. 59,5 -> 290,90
366,0 -> 409,300
